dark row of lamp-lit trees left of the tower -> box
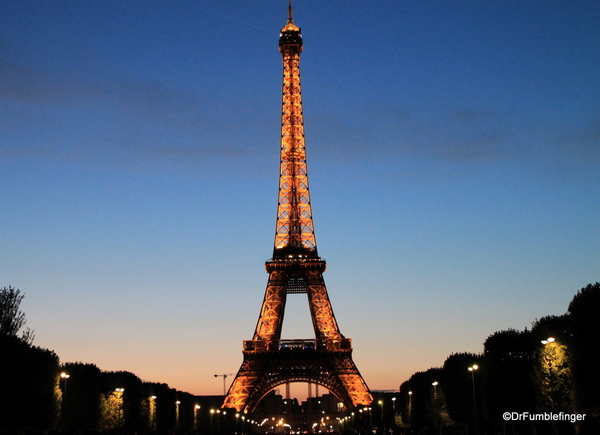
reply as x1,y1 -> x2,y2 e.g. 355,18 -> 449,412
0,287 -> 229,434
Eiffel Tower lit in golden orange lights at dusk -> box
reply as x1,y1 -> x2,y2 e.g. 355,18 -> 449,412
223,0 -> 373,412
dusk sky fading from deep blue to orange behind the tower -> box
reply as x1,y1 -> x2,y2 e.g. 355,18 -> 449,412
0,0 -> 600,400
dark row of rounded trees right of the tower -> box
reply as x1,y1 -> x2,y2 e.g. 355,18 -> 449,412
398,283 -> 600,435
